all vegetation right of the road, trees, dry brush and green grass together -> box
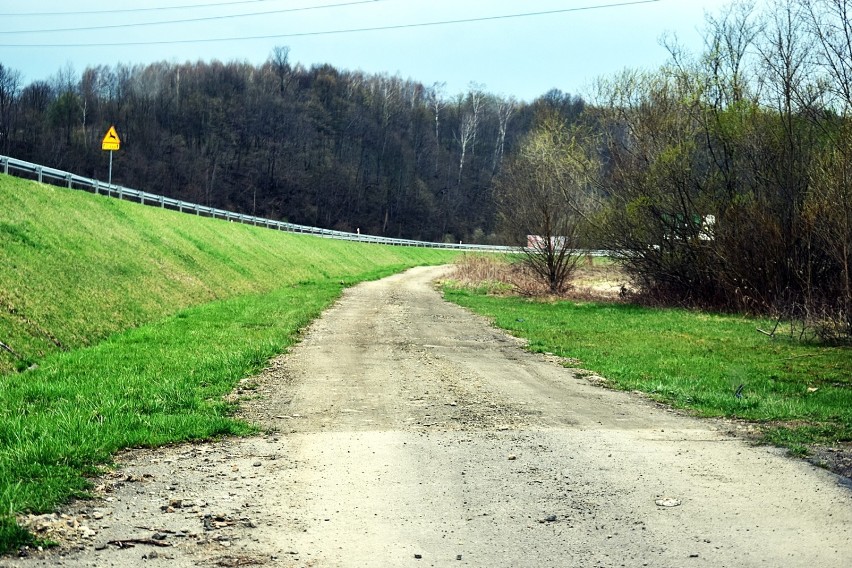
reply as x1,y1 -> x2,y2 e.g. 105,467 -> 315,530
476,0 -> 852,466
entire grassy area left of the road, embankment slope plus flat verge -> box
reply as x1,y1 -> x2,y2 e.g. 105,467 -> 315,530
0,175 -> 455,551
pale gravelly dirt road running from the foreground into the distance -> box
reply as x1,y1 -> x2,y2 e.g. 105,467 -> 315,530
5,268 -> 852,568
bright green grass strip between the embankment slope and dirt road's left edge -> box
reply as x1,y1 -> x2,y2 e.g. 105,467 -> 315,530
0,280 -> 342,511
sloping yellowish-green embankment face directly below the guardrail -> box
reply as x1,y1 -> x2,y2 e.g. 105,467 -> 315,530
0,175 -> 450,373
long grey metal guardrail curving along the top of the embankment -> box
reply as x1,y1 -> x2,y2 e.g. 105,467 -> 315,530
0,155 -> 609,256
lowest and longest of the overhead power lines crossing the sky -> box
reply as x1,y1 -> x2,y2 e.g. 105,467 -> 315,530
0,0 -> 662,48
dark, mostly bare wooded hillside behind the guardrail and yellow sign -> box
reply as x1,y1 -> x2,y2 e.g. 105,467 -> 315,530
0,47 -> 584,242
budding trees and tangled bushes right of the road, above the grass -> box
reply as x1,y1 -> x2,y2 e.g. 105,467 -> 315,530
486,0 -> 852,345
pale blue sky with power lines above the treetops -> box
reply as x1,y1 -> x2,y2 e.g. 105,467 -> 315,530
0,0 -> 730,101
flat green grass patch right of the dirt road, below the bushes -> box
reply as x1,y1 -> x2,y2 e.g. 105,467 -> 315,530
445,287 -> 852,453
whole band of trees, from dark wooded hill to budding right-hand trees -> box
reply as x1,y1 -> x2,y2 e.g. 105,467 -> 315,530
0,0 -> 852,340
